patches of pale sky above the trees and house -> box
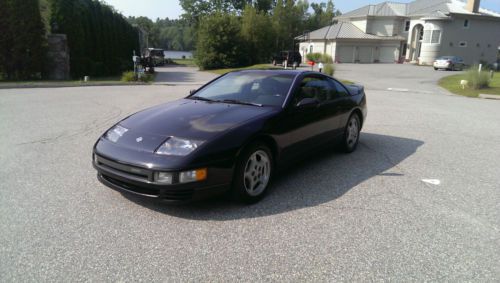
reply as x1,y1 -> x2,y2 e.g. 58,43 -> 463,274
105,0 -> 500,20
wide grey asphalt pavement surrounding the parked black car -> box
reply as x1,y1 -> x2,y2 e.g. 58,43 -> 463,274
0,65 -> 500,282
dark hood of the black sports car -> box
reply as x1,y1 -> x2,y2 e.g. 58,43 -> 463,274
118,99 -> 277,151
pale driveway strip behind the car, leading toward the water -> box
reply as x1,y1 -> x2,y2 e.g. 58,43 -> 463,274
154,65 -> 217,85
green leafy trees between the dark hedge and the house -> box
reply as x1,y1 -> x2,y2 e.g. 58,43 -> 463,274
128,0 -> 340,69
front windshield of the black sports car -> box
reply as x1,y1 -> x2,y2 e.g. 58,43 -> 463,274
190,72 -> 294,106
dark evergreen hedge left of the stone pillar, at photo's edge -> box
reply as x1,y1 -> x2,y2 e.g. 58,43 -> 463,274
0,0 -> 46,80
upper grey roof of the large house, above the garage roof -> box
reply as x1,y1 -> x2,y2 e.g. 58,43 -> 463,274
335,0 -> 500,19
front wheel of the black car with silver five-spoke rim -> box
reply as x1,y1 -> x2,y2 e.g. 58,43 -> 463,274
232,143 -> 274,204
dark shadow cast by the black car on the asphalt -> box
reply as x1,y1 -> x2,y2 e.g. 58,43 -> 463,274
123,133 -> 424,221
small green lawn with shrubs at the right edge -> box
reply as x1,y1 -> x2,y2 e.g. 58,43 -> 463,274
439,72 -> 500,97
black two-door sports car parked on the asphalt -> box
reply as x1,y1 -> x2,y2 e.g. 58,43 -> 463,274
93,70 -> 367,203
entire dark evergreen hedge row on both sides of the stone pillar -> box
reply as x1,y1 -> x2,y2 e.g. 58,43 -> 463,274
0,0 -> 140,80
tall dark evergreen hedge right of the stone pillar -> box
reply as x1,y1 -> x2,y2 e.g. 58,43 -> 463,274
50,0 -> 139,78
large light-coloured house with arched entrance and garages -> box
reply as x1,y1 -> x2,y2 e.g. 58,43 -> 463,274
296,0 -> 500,65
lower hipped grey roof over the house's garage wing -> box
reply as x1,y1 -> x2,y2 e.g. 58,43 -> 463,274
295,22 -> 405,41
